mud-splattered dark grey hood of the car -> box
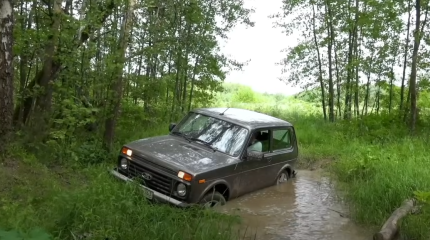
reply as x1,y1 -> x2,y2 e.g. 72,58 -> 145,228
126,135 -> 239,174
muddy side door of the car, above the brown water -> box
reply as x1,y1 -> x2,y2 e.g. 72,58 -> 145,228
238,129 -> 270,195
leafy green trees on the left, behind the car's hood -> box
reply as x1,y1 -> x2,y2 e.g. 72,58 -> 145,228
13,0 -> 253,156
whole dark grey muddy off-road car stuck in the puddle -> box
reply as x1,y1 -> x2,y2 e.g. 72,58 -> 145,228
111,108 -> 298,207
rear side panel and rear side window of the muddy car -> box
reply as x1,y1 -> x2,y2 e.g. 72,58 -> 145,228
264,127 -> 297,185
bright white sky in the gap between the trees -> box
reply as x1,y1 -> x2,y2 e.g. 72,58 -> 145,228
221,0 -> 301,95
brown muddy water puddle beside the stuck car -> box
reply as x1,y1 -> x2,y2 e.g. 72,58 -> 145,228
220,170 -> 372,240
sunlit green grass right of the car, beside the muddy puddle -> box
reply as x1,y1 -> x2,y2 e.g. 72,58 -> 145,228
217,84 -> 430,239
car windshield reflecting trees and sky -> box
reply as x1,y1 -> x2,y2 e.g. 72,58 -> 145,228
173,113 -> 248,156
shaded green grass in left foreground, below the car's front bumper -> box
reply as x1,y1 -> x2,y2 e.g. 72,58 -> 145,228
0,161 -> 242,240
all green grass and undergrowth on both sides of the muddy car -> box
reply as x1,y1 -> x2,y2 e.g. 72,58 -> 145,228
0,95 -> 430,240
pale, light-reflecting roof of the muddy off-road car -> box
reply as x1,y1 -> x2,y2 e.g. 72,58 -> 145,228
192,108 -> 293,128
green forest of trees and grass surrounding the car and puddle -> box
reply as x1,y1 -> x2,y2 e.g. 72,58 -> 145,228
0,0 -> 430,240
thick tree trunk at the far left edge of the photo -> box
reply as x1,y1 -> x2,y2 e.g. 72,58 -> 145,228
0,0 -> 14,153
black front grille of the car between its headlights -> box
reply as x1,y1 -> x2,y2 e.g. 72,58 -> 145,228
128,158 -> 173,196
